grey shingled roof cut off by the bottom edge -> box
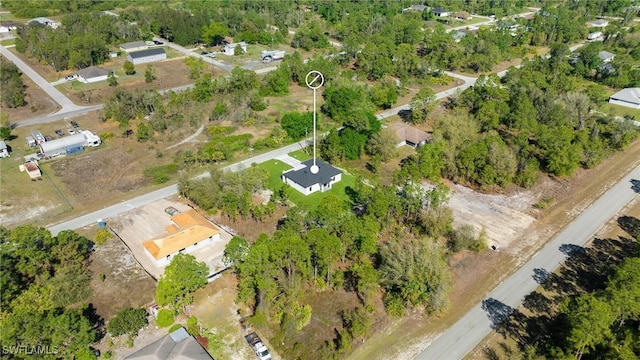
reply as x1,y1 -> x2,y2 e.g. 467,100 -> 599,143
125,327 -> 212,360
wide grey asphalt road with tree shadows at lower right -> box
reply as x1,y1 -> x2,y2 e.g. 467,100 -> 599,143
416,166 -> 640,360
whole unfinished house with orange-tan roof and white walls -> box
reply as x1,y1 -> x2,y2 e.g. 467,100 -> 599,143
142,210 -> 220,267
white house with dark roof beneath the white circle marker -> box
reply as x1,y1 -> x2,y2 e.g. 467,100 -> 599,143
281,159 -> 342,195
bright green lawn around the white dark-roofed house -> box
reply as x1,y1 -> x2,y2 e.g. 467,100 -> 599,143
258,160 -> 356,211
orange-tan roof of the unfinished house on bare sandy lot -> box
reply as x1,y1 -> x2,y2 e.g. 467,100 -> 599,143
142,210 -> 220,259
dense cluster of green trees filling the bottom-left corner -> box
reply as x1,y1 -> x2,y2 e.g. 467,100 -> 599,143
0,225 -> 96,358
